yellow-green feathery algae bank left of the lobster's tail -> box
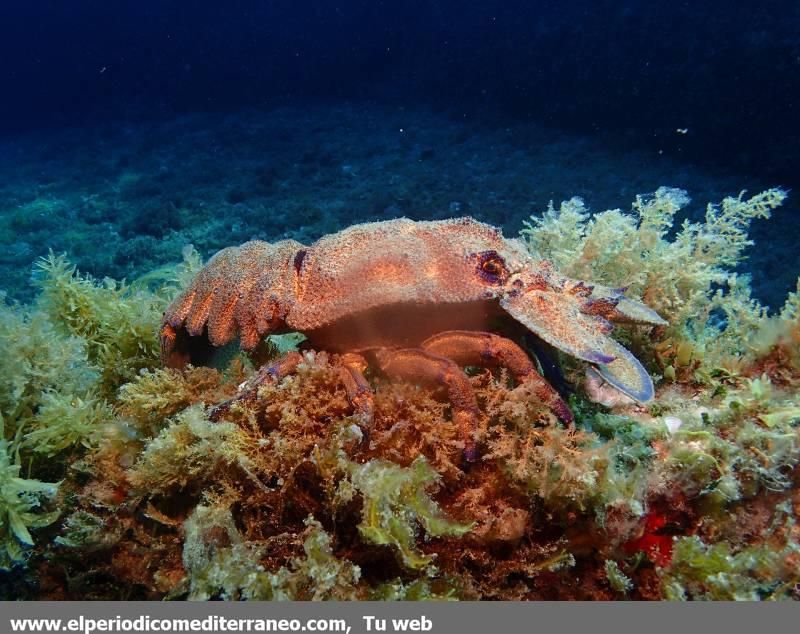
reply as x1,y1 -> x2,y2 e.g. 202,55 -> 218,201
0,246 -> 199,569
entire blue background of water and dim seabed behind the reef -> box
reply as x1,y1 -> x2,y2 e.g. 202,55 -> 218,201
0,0 -> 800,305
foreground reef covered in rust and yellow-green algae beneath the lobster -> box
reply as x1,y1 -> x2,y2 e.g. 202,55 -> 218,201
0,188 -> 800,600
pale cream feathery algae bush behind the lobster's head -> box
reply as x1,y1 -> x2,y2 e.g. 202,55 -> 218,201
522,187 -> 787,372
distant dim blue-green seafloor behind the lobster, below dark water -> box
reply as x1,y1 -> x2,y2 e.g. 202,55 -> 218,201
0,104 -> 797,308
